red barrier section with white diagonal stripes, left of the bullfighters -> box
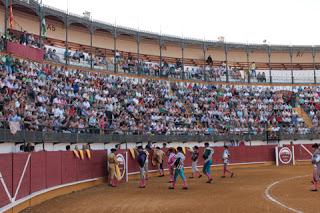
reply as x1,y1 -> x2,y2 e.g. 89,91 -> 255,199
0,150 -> 106,212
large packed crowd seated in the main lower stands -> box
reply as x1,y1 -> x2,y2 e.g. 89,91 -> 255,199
0,55 -> 320,135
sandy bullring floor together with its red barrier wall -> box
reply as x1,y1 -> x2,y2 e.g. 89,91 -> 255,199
1,145 -> 319,212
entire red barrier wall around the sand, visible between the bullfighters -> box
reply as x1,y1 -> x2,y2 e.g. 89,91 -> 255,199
0,144 -> 312,212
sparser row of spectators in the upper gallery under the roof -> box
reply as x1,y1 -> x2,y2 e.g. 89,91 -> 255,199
45,46 -> 267,83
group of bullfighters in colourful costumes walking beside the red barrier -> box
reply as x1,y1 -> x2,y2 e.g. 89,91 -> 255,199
108,143 -> 234,190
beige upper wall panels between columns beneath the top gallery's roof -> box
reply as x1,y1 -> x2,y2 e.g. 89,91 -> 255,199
0,6 -> 320,63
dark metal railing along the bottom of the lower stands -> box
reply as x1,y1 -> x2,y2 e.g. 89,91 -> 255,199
0,129 -> 320,143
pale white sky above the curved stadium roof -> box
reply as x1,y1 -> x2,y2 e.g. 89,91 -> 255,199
43,0 -> 320,45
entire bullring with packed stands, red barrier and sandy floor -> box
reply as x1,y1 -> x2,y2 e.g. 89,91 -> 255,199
0,0 -> 320,213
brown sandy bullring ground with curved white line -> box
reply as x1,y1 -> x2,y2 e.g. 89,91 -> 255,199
24,164 -> 320,213
